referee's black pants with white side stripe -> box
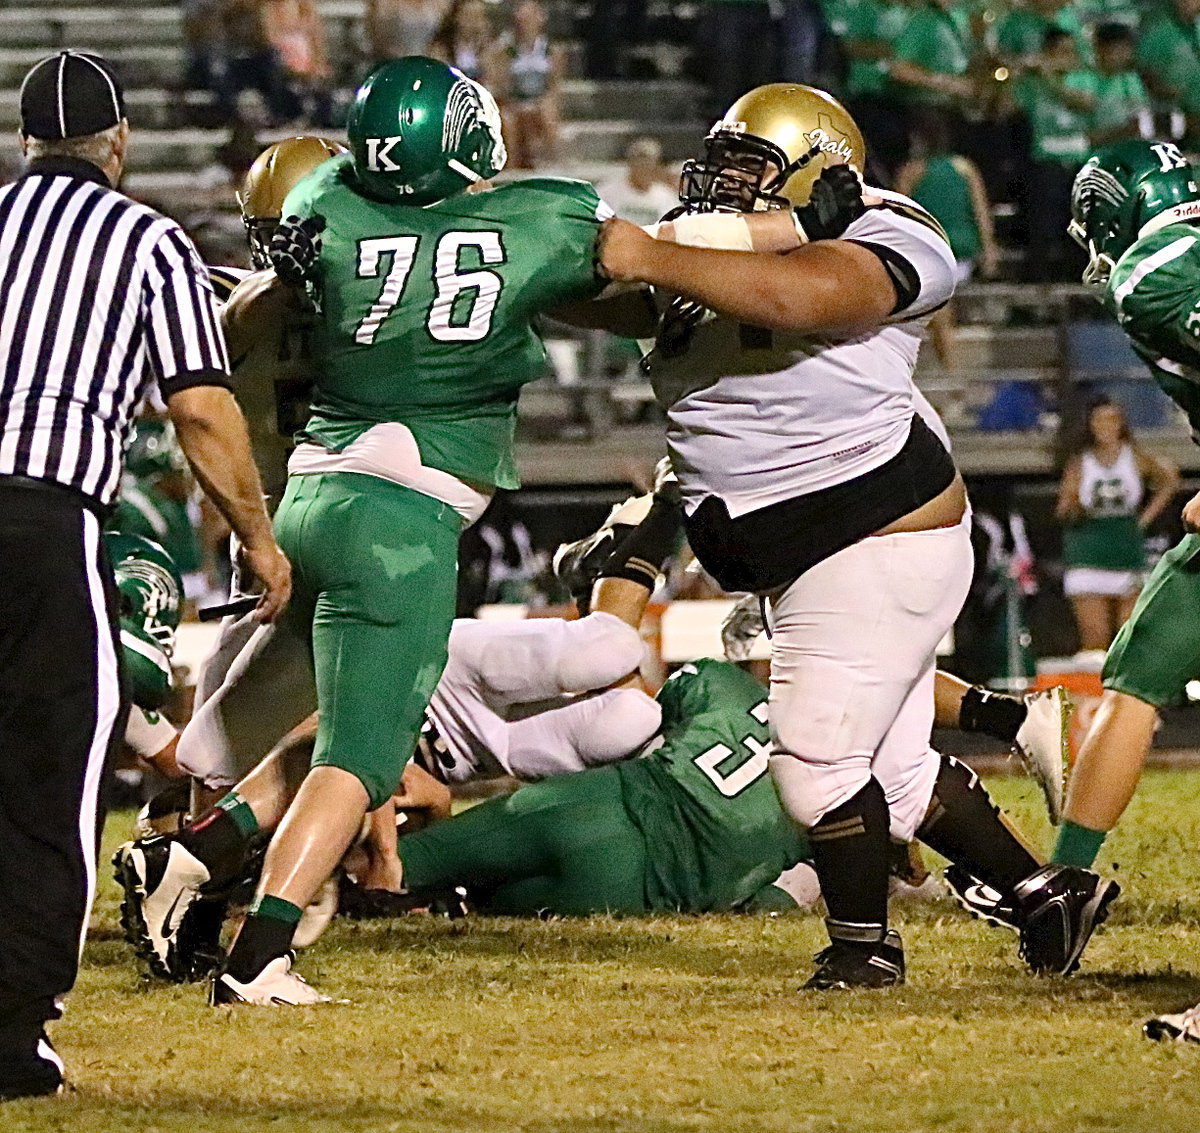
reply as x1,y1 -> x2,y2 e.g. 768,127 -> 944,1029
0,476 -> 126,1057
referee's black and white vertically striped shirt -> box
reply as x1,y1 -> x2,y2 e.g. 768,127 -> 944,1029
0,157 -> 229,504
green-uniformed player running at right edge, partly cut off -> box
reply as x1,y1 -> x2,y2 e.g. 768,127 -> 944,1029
1054,142 -> 1200,1042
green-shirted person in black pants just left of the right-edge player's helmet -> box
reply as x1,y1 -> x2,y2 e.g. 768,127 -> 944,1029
1015,28 -> 1098,282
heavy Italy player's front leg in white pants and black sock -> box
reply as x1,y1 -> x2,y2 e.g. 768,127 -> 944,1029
770,526 -> 972,987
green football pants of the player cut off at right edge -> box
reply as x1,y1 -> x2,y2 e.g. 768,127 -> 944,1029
1103,535 -> 1200,708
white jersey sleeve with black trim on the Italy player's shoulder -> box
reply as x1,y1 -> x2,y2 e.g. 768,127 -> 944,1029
841,188 -> 955,323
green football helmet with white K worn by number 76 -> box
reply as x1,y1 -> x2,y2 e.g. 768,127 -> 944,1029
346,55 -> 508,205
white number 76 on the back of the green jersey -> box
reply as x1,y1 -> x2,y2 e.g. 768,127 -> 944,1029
354,232 -> 508,346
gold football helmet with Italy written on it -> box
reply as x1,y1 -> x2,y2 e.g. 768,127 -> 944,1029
679,83 -> 866,212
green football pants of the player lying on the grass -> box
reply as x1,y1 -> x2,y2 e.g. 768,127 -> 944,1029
400,767 -> 647,917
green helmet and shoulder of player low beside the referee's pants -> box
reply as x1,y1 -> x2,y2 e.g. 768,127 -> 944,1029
104,532 -> 184,708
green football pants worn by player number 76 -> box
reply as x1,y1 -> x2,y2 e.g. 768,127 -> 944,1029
275,472 -> 462,809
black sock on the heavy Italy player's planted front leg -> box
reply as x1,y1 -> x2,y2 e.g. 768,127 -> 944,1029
809,778 -> 892,948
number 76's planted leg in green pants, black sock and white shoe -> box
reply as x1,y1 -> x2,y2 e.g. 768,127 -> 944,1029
214,474 -> 461,1002
